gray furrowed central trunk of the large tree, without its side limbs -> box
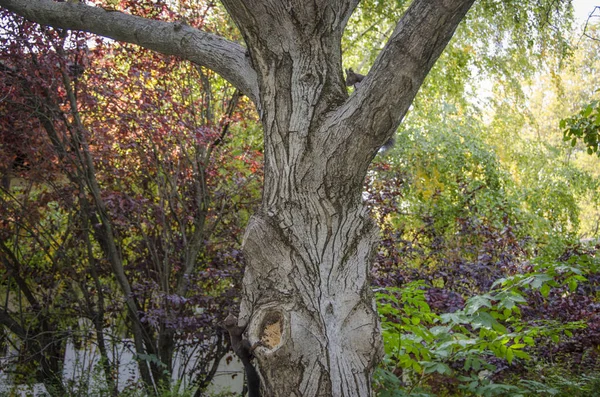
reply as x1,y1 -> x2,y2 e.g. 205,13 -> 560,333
216,2 -> 382,397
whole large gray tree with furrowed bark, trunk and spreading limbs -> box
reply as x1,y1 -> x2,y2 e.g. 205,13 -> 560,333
0,0 -> 474,397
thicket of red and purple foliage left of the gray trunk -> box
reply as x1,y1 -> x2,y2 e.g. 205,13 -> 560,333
0,6 -> 261,396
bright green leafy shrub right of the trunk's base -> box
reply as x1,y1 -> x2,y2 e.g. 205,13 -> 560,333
375,255 -> 585,396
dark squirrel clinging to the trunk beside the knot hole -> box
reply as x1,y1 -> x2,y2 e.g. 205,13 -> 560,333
222,313 -> 262,397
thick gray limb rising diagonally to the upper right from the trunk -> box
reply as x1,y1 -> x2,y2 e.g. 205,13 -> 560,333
328,0 -> 474,155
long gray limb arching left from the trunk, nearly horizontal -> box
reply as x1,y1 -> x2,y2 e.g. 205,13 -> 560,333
0,0 -> 258,103
